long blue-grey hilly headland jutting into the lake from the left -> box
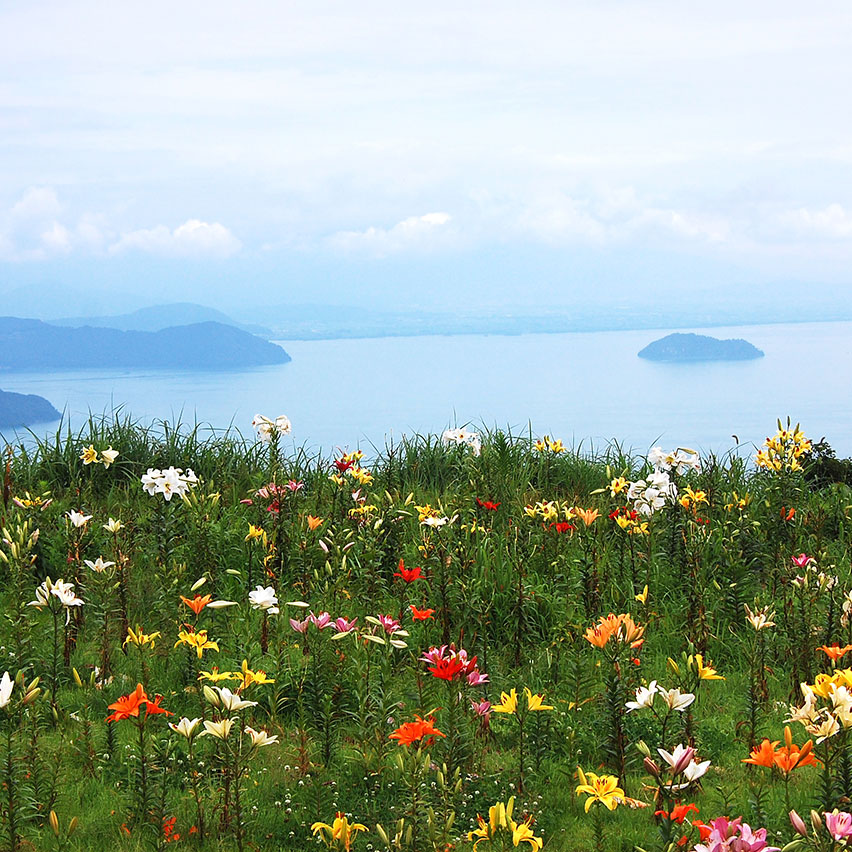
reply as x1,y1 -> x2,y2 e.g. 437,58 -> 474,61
0,317 -> 290,370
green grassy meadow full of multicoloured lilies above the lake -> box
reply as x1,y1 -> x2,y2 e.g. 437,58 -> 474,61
5,415 -> 852,852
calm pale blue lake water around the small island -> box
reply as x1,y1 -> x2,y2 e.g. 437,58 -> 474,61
0,322 -> 852,455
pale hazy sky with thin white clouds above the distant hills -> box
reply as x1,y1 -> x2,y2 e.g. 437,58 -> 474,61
0,0 -> 852,318
